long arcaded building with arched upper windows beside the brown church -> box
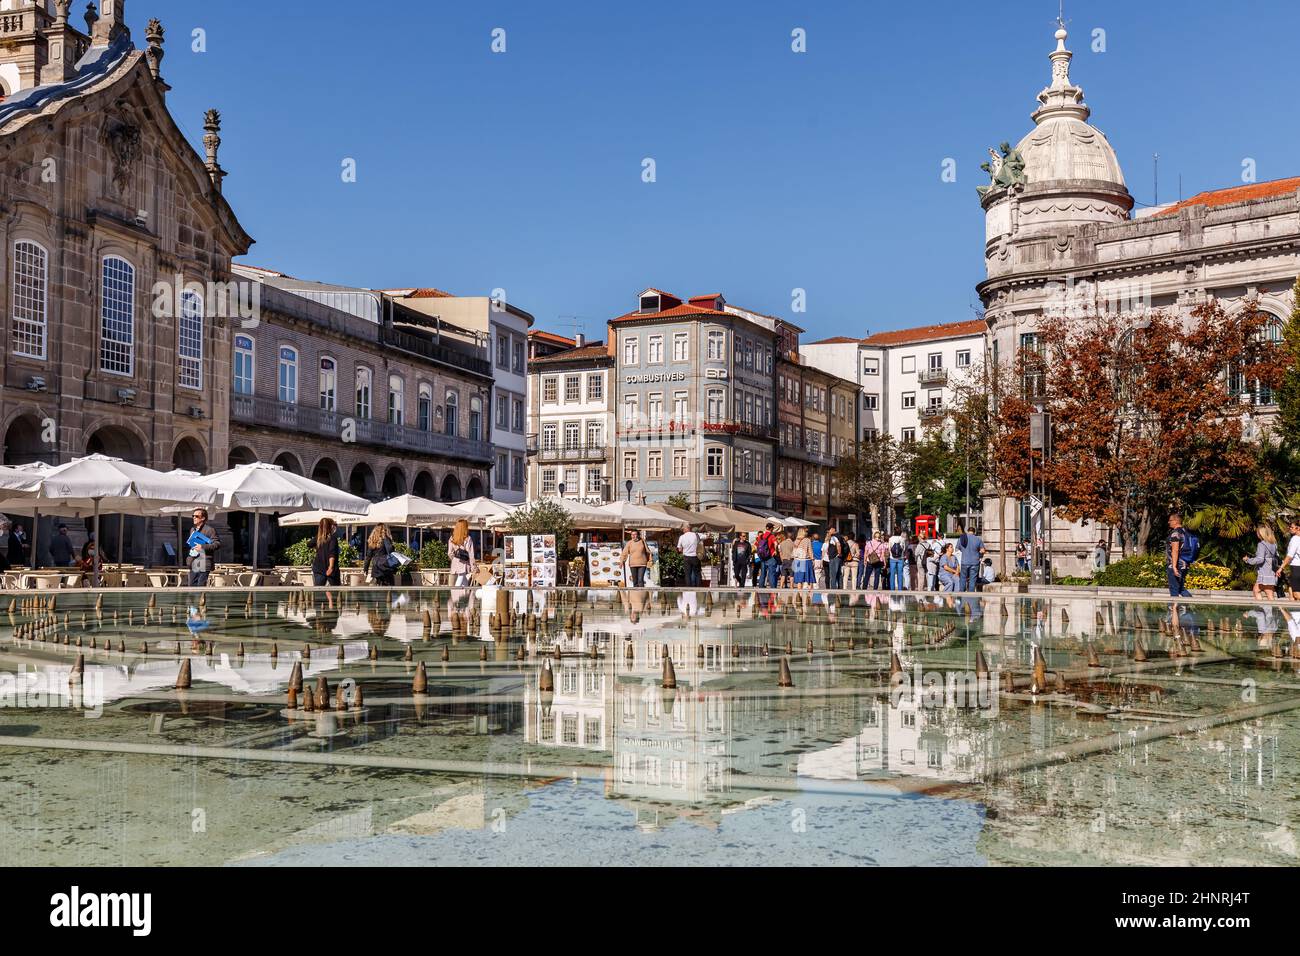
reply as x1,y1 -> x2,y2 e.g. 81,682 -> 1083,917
229,265 -> 494,559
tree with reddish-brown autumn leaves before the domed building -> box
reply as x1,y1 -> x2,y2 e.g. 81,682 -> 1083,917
995,300 -> 1286,554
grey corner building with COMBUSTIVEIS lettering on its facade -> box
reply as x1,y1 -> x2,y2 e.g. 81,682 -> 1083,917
608,289 -> 777,509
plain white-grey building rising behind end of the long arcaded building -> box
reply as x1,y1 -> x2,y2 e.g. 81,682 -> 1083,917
385,287 -> 533,505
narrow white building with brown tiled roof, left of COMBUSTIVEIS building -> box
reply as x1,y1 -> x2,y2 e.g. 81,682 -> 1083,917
528,333 -> 618,506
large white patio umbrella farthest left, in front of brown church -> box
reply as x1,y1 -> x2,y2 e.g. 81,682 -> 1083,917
0,455 -> 215,583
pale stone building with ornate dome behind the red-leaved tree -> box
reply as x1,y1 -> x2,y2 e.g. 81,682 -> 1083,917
976,26 -> 1300,575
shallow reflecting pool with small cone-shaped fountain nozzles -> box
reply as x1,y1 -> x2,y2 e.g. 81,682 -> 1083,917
0,589 -> 1300,865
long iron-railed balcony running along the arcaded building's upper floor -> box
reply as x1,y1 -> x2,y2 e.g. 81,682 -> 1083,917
230,395 -> 493,463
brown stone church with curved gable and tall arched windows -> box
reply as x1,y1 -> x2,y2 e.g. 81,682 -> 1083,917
0,0 -> 252,561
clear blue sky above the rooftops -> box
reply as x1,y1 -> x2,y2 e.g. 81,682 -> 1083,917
159,0 -> 1300,341
